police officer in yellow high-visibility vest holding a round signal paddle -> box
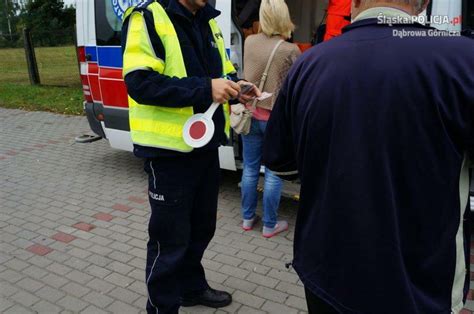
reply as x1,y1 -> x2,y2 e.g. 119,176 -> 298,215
122,0 -> 260,313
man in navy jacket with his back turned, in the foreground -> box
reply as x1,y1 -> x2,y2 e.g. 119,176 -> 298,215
264,0 -> 474,314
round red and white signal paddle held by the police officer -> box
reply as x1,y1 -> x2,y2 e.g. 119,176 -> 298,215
183,102 -> 220,148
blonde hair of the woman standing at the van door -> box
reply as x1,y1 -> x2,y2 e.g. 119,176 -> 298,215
260,0 -> 295,38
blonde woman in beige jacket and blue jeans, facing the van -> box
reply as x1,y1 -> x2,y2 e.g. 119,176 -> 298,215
242,0 -> 300,238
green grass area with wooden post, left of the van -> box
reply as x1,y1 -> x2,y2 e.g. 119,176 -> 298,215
0,46 -> 83,115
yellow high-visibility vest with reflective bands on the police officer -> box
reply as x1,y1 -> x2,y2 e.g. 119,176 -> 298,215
123,1 -> 235,152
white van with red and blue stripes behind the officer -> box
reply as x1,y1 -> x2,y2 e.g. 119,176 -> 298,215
76,0 -> 474,170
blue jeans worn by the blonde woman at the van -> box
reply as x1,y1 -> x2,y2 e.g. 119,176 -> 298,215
242,119 -> 282,228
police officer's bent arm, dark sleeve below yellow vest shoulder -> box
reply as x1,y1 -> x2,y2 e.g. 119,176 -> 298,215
122,10 -> 238,107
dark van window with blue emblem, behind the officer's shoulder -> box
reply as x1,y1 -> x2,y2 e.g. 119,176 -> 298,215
95,0 -> 140,46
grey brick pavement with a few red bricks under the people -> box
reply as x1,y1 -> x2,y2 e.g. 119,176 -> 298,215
0,108 -> 474,314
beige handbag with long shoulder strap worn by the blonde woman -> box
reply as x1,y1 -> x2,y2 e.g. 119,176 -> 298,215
230,39 -> 283,135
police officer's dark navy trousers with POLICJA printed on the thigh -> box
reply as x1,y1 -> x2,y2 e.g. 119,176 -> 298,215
145,149 -> 220,314
